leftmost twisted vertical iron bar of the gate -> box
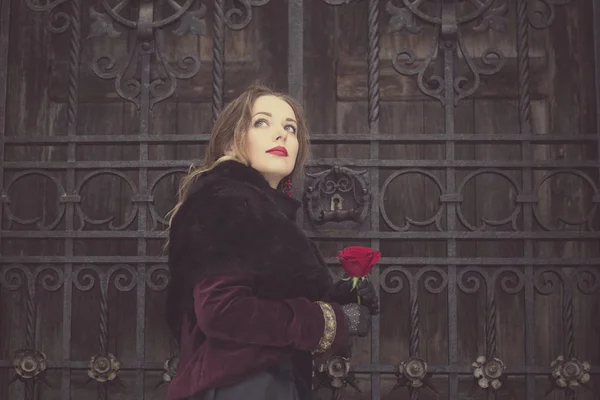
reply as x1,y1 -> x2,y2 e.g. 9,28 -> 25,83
61,0 -> 81,399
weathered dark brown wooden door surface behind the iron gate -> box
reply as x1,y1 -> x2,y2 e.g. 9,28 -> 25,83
0,0 -> 600,400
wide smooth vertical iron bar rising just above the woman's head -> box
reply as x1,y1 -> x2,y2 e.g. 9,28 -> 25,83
288,0 -> 304,227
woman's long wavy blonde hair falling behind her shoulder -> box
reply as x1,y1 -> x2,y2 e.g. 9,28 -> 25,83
167,85 -> 310,228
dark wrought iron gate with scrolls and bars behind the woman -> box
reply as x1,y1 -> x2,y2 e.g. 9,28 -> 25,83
0,0 -> 600,400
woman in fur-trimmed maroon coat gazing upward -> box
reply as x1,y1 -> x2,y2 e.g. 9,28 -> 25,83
167,86 -> 378,400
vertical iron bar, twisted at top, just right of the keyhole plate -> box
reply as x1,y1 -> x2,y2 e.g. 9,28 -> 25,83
367,0 -> 381,399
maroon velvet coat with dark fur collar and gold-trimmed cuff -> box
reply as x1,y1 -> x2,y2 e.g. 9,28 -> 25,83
167,161 -> 351,400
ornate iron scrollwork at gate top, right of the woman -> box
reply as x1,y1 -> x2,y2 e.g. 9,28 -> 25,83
386,0 -> 508,106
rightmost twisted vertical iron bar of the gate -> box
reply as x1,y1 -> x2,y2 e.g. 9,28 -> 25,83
517,0 -> 535,400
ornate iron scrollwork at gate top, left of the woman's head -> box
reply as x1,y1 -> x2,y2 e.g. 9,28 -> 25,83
90,0 -> 206,109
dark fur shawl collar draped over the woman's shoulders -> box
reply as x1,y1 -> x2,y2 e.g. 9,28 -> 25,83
169,161 -> 331,300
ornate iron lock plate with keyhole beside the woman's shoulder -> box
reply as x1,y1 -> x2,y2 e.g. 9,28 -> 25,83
306,165 -> 371,224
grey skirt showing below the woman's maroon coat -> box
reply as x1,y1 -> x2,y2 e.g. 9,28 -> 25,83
188,360 -> 312,400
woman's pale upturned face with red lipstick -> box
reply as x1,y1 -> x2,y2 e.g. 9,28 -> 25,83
246,96 -> 298,188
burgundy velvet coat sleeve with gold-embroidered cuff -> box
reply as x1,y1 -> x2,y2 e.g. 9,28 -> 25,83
194,274 -> 344,351
